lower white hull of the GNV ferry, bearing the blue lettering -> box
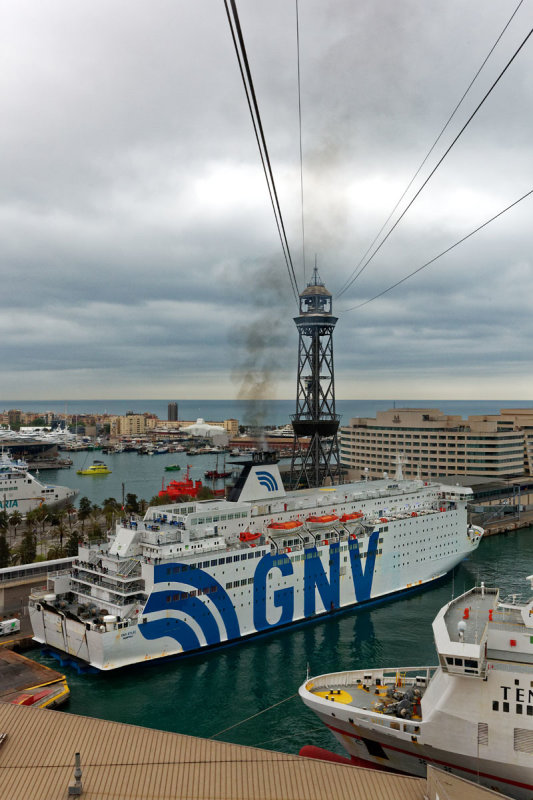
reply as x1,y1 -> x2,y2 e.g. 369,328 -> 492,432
29,532 -> 472,671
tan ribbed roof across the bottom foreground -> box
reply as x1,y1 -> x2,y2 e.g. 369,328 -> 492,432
0,703 -> 510,800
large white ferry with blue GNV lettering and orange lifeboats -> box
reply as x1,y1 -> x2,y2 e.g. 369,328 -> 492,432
29,453 -> 483,670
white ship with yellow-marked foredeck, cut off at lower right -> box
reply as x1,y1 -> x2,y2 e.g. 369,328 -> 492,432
300,575 -> 533,800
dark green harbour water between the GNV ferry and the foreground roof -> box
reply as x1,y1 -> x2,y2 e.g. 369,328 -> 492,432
30,524 -> 533,753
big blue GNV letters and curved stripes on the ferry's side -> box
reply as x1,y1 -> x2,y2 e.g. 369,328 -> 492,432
139,531 -> 379,652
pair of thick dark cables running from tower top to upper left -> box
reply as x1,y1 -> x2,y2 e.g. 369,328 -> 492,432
224,0 -> 299,303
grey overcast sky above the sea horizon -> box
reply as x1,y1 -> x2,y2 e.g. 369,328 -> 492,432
0,0 -> 533,405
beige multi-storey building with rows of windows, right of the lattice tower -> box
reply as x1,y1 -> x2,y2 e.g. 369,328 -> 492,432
340,408 -> 533,480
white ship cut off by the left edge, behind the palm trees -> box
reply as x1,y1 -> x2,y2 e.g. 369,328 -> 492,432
0,450 -> 78,514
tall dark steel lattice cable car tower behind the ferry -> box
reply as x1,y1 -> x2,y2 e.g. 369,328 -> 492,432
290,266 -> 340,489
